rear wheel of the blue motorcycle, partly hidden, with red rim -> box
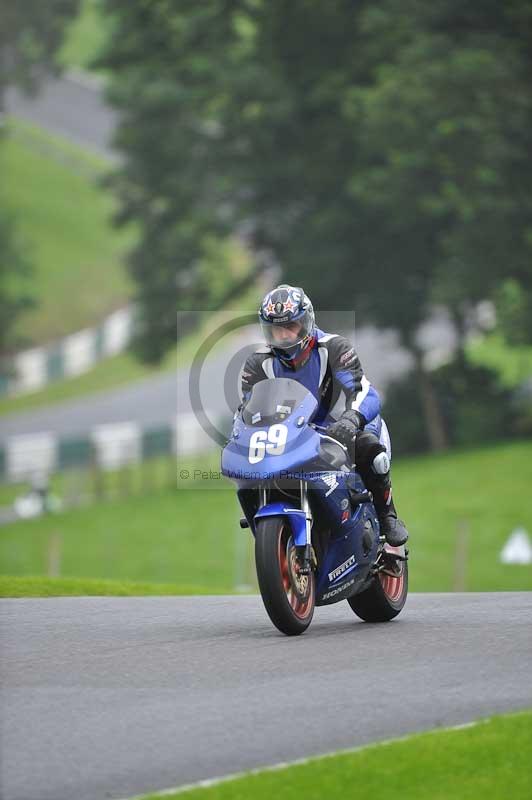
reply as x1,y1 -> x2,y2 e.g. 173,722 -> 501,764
347,544 -> 408,622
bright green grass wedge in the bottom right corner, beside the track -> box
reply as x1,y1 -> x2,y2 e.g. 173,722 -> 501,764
137,712 -> 532,800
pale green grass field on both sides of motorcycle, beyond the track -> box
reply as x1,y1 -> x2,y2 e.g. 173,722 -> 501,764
0,441 -> 532,592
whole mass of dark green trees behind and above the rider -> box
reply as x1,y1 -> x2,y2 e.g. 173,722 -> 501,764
102,0 -> 532,446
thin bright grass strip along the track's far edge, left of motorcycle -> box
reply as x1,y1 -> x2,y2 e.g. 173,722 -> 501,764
0,575 -> 231,597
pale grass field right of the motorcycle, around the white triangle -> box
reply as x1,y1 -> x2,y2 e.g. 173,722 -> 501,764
400,440 -> 532,592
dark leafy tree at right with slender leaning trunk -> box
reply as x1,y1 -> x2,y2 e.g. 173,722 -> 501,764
338,0 -> 532,446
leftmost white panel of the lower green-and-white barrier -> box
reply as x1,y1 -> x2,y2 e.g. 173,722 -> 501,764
6,433 -> 57,480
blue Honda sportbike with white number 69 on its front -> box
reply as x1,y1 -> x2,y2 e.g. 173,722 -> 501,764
222,378 -> 408,636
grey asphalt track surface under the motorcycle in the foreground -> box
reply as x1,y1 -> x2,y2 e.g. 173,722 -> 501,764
0,592 -> 532,800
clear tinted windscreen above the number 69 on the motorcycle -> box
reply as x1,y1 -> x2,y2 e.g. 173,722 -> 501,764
242,378 -> 310,425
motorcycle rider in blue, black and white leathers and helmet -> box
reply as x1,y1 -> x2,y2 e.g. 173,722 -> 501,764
242,284 -> 408,546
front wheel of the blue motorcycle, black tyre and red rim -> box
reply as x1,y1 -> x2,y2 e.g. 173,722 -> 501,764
255,517 -> 316,636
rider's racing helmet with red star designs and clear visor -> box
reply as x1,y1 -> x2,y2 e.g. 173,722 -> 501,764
259,283 -> 316,369
